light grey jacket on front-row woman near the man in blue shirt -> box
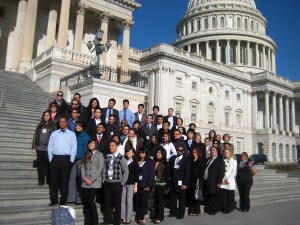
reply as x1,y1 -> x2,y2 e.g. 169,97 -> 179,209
81,151 -> 105,188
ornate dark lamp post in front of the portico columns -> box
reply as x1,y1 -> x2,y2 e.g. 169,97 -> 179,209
87,28 -> 111,77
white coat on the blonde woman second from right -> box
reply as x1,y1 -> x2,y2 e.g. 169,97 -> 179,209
221,158 -> 237,190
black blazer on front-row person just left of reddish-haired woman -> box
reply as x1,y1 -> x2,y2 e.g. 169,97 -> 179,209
169,155 -> 191,189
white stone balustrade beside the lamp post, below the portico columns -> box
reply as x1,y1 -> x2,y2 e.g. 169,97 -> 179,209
31,46 -> 96,68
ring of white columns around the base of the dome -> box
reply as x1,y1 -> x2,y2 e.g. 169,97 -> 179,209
184,39 -> 276,73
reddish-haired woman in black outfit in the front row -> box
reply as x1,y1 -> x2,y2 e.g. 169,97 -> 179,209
187,147 -> 205,216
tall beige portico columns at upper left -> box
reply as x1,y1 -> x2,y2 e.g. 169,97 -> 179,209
12,0 -> 133,70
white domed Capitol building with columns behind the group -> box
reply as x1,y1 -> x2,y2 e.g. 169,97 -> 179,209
0,0 -> 300,162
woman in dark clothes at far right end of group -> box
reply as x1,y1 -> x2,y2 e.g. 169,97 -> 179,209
236,152 -> 256,212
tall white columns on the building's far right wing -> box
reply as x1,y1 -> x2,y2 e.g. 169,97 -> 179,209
252,91 -> 296,133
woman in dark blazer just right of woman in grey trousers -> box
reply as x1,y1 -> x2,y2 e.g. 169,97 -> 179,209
135,147 -> 154,225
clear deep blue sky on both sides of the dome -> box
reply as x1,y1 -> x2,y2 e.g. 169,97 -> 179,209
131,0 -> 300,80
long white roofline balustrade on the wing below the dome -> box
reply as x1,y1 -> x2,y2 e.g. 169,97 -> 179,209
142,44 -> 251,81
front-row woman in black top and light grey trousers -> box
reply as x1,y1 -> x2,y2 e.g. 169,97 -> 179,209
121,147 -> 140,224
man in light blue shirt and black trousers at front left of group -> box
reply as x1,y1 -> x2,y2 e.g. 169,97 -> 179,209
48,116 -> 77,206
